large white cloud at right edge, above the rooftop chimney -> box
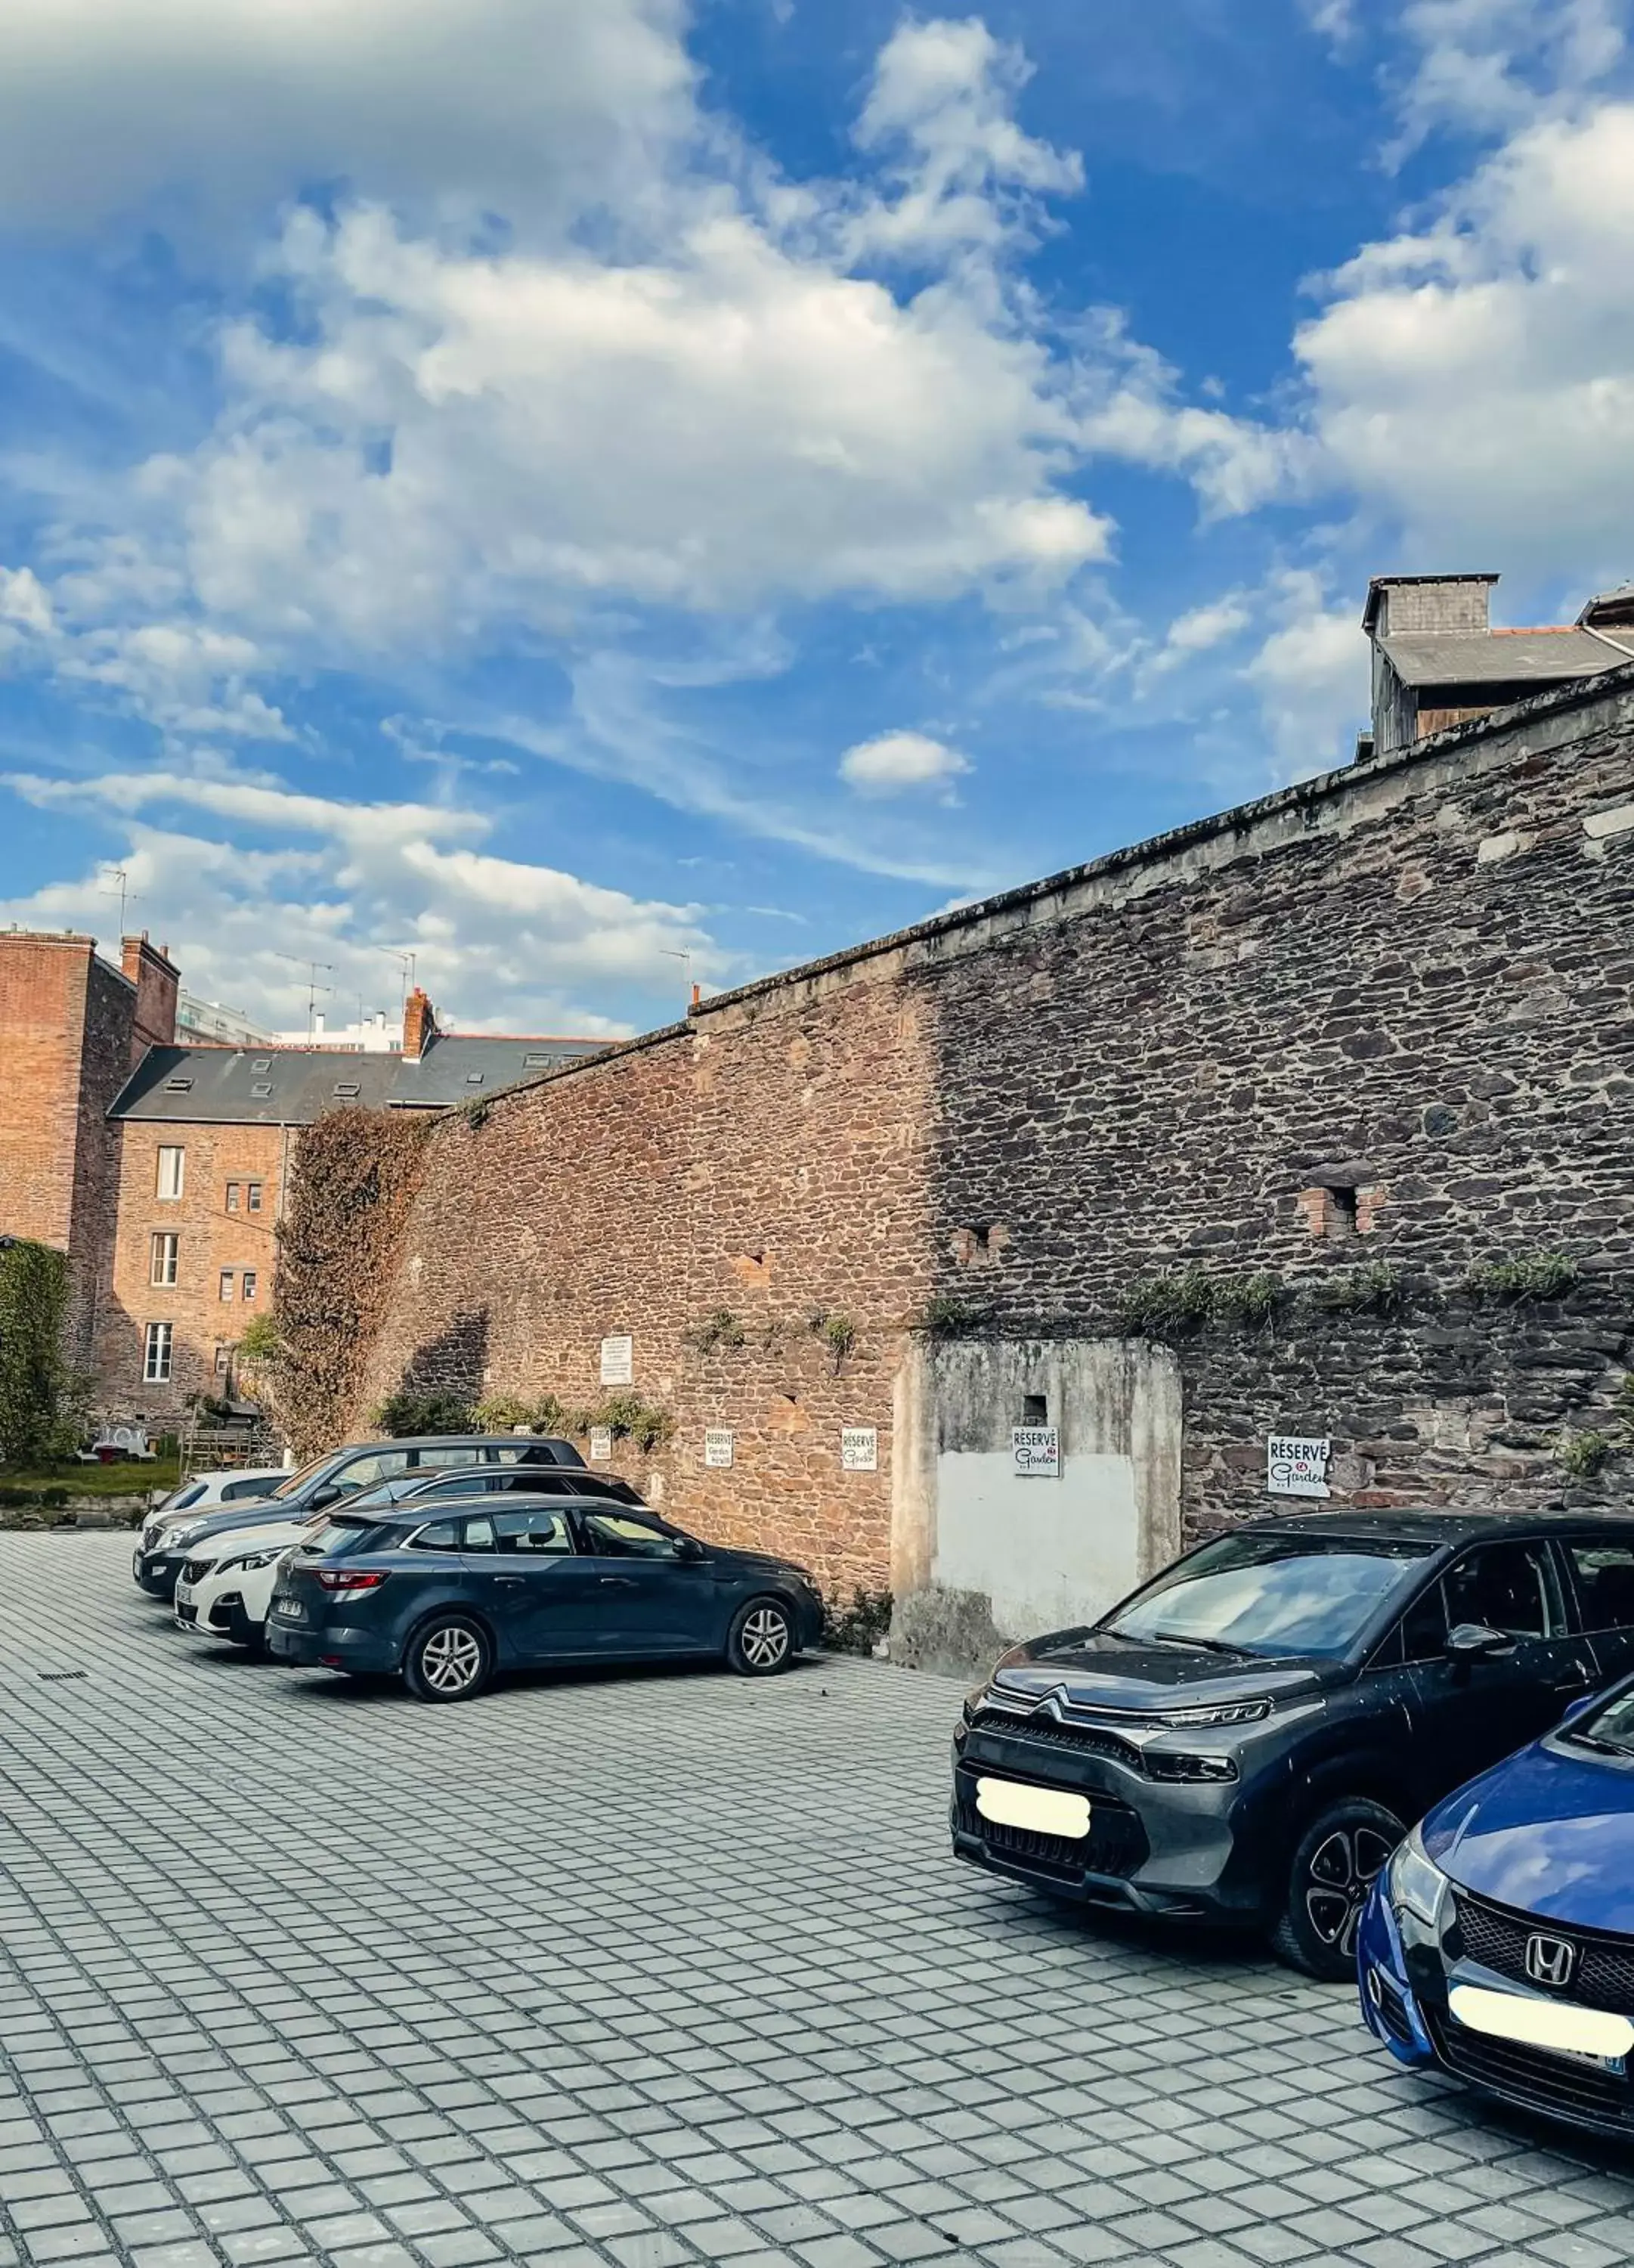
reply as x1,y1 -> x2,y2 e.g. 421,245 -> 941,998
1294,100 -> 1634,594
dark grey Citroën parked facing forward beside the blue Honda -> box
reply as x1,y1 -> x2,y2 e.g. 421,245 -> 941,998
952,1513 -> 1634,1980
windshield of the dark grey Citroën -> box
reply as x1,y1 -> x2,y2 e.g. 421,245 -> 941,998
1099,1533 -> 1432,1656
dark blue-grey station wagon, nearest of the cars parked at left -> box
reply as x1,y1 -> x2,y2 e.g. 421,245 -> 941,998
268,1497 -> 822,1701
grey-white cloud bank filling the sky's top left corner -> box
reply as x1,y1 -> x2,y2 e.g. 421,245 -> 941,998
0,0 -> 694,229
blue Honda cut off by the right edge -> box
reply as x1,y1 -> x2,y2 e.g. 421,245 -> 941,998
1355,1678 -> 1634,2141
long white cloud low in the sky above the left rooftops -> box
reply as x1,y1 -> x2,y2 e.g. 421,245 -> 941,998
0,771 -> 716,1036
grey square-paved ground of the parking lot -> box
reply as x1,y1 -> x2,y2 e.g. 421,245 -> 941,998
0,1535 -> 1634,2268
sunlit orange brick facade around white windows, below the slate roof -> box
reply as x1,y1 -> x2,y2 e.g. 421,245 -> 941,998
97,1118 -> 295,1424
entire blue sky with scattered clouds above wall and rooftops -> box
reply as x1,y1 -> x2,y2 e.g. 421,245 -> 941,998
0,0 -> 1634,1032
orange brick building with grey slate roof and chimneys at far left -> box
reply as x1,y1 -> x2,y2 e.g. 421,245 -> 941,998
0,932 -> 601,1427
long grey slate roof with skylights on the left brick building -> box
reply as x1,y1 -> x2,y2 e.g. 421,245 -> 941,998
109,1032 -> 605,1127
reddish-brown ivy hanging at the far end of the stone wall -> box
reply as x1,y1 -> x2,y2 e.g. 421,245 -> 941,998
272,1109 -> 431,1456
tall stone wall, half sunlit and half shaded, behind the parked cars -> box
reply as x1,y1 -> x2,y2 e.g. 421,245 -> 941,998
339,665 -> 1634,1660
